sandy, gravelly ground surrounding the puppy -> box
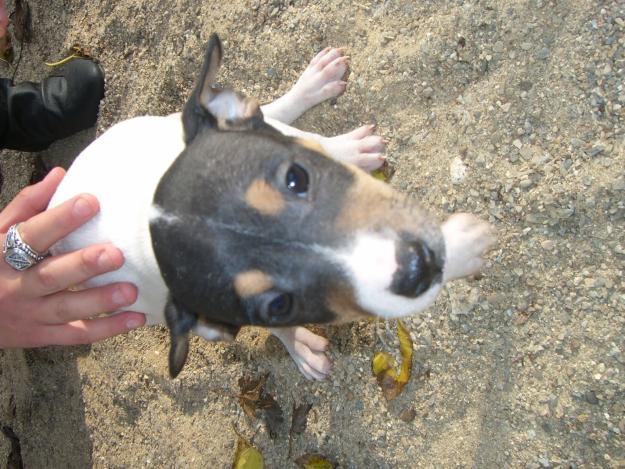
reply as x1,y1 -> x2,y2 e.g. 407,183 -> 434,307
0,0 -> 625,468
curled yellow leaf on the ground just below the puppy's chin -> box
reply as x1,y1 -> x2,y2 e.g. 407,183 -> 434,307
373,321 -> 412,401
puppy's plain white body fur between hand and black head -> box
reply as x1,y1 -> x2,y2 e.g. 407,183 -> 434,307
50,114 -> 184,324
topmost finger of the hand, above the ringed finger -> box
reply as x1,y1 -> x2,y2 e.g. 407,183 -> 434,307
0,168 -> 65,232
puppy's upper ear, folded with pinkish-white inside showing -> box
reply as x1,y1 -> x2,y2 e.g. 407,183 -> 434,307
182,34 -> 262,145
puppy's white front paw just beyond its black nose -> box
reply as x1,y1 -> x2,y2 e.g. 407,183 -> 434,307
442,213 -> 495,282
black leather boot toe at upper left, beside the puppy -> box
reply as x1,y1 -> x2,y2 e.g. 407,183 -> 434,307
0,59 -> 104,151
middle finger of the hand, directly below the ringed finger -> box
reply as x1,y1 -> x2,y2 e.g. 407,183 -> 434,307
23,244 -> 124,297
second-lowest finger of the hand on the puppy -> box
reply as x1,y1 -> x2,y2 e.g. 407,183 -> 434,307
36,283 -> 137,325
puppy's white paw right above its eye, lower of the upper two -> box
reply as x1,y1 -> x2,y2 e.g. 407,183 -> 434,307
320,125 -> 388,171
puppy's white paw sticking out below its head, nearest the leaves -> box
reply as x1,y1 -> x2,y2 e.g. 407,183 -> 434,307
269,326 -> 332,381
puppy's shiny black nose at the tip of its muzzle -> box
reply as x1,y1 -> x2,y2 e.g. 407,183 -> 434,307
391,241 -> 443,298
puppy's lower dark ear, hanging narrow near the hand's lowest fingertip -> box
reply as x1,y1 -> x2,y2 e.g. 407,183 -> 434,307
165,298 -> 197,378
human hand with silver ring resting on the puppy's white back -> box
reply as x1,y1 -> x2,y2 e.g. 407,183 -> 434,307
0,168 -> 145,348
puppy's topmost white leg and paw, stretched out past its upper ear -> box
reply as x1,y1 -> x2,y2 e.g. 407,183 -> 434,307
261,47 -> 349,124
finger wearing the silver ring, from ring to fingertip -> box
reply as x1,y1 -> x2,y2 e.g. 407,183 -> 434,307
19,194 -> 100,253
